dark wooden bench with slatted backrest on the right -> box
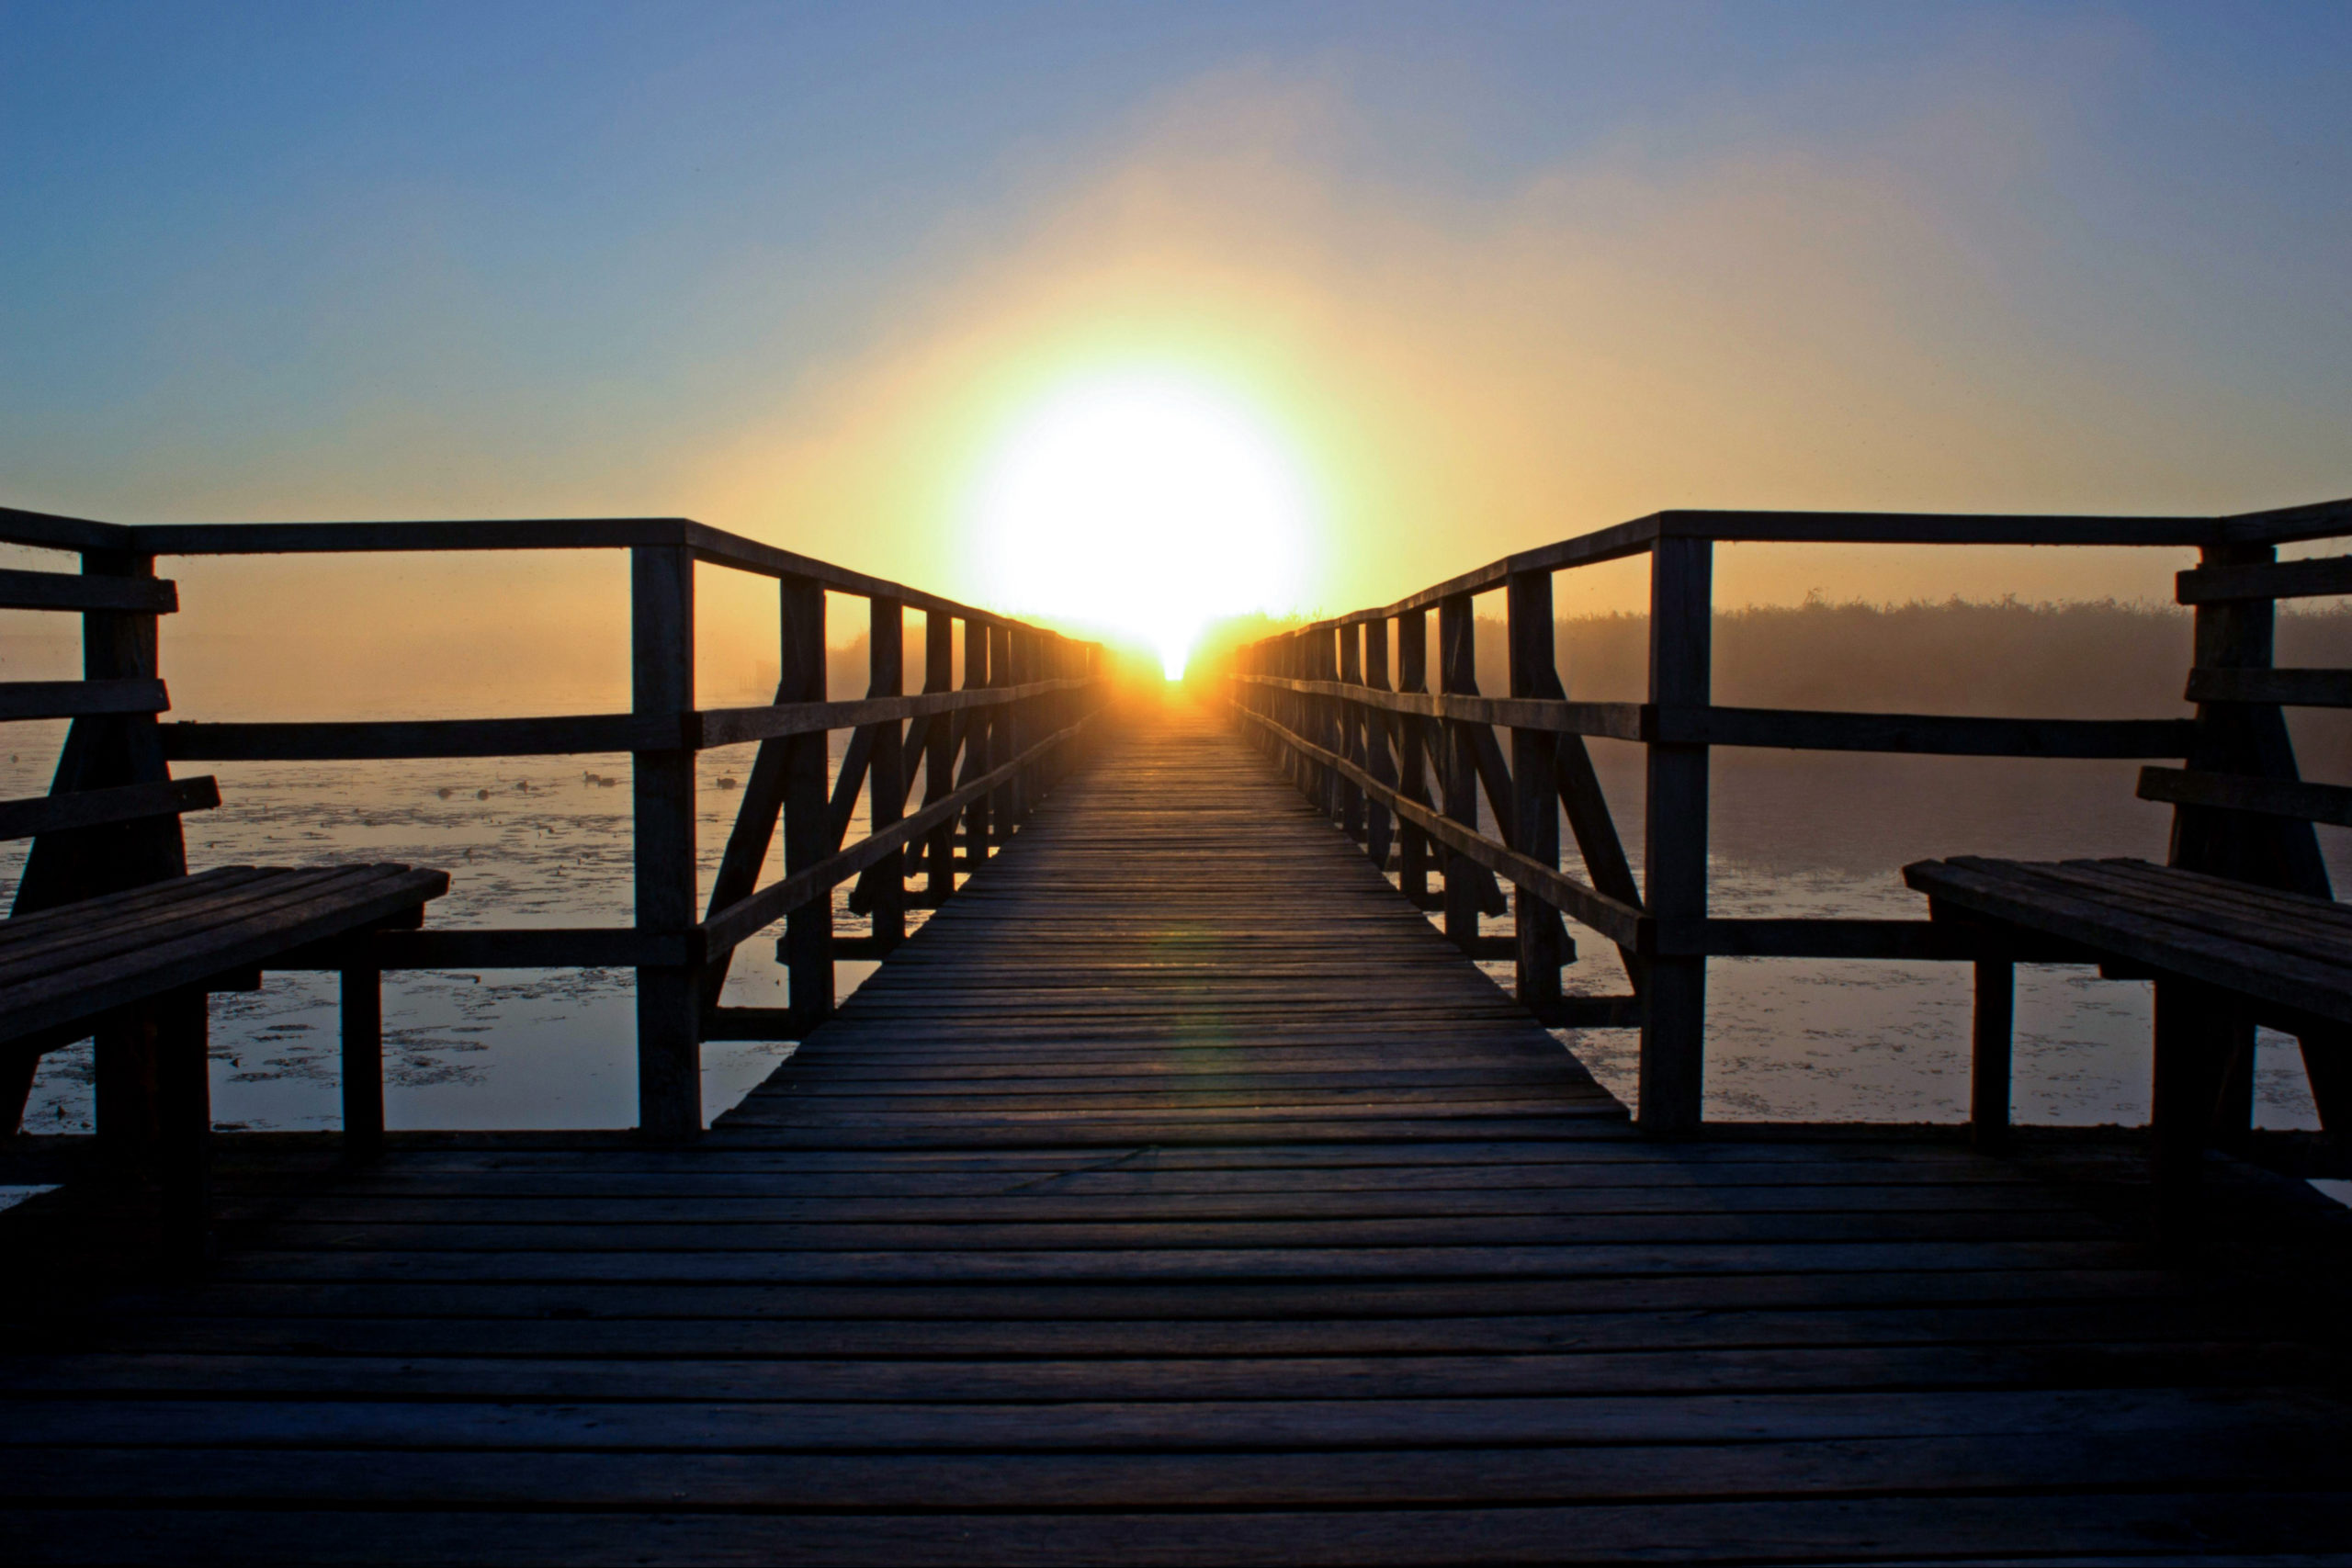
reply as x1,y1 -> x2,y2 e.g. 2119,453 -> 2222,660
1903,546 -> 2352,1218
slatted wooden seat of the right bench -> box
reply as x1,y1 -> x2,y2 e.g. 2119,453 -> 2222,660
1903,856 -> 2352,1022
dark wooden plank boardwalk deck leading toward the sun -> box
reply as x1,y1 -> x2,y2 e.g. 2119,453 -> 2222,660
0,710 -> 2352,1563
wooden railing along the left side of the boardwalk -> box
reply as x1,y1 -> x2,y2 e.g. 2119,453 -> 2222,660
0,508 -> 1105,1138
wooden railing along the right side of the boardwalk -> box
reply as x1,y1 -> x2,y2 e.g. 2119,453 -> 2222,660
1226,501 -> 2352,1131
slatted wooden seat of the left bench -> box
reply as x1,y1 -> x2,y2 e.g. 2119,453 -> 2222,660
0,865 -> 449,1042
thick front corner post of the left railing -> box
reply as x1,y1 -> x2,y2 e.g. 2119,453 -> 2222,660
628,546 -> 703,1138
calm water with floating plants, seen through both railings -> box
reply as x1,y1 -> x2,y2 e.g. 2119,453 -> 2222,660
0,727 -> 2352,1131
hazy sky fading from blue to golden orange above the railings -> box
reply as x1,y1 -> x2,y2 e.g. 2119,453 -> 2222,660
0,0 -> 2352,682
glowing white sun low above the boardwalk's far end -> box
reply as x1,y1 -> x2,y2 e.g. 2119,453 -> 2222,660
976,374 -> 1312,680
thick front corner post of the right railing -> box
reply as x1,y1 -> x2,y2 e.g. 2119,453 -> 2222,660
1637,536 -> 1714,1134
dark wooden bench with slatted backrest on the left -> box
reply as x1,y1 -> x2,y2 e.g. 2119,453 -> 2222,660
0,541 -> 449,1262
